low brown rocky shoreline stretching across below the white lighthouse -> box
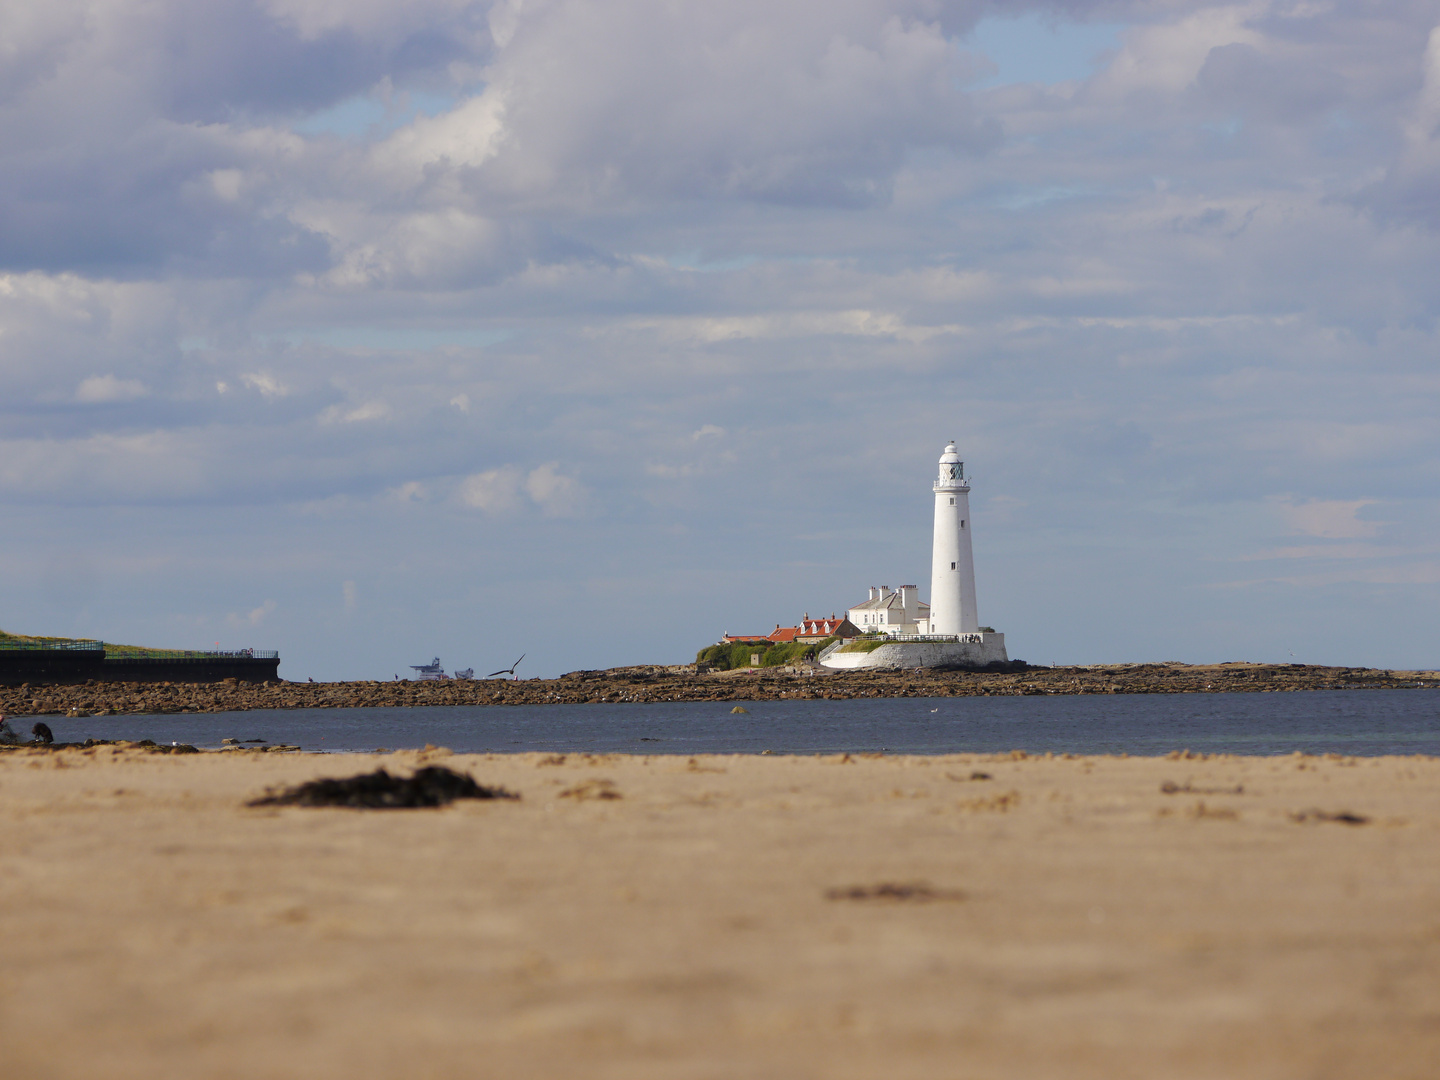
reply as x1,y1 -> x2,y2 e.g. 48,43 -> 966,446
0,662 -> 1440,717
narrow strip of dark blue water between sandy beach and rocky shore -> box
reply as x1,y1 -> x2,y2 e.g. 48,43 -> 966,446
46,690 -> 1440,755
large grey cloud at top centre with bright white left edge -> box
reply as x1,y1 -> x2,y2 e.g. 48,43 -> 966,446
435,0 -> 998,204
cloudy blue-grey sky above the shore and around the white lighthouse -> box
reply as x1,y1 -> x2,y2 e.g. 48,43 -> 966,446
0,0 -> 1440,680
